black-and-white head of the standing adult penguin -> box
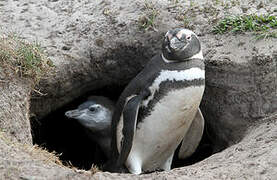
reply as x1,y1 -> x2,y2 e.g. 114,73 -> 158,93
162,28 -> 202,61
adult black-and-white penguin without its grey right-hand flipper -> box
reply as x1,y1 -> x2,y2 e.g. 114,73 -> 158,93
108,28 -> 205,174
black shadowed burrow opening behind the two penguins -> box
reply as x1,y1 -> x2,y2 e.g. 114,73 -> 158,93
31,84 -> 213,170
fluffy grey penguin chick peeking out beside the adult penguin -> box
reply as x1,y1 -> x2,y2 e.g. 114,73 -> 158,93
65,96 -> 115,158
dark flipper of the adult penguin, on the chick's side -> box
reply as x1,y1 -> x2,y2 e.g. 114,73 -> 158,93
117,91 -> 149,167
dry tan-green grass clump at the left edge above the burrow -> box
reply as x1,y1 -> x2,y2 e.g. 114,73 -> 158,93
0,35 -> 53,84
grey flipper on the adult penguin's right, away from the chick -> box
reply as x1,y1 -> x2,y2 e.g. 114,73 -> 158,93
178,108 -> 204,159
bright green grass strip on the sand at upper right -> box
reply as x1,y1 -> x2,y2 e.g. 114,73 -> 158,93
213,14 -> 277,37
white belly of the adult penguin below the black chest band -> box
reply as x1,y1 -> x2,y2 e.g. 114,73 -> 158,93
133,86 -> 204,170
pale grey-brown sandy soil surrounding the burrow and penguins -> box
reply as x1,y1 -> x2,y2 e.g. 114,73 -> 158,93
0,0 -> 277,179
